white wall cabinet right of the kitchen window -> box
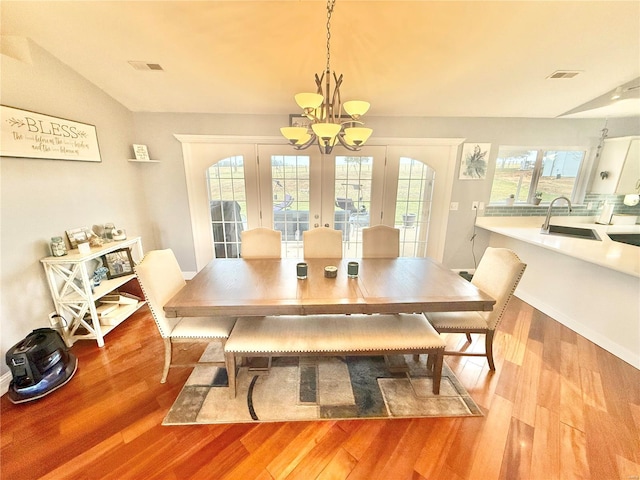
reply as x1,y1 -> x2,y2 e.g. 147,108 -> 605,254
591,136 -> 640,195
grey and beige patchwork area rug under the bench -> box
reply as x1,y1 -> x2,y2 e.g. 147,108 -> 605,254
162,344 -> 482,425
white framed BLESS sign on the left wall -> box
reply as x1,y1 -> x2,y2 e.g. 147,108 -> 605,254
0,105 -> 102,162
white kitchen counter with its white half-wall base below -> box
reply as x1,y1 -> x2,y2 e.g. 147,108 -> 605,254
476,216 -> 640,368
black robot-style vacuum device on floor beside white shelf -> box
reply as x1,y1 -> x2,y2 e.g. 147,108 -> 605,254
6,328 -> 78,403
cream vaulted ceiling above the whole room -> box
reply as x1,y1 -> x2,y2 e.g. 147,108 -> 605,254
0,0 -> 640,117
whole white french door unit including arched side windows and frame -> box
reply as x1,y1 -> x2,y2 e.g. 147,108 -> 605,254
176,135 -> 462,270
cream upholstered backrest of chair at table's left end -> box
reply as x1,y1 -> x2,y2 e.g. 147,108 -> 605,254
135,249 -> 186,338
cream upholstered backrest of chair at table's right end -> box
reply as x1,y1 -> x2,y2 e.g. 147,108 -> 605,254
471,247 -> 527,330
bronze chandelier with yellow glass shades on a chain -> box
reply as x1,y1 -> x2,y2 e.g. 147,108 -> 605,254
280,0 -> 373,154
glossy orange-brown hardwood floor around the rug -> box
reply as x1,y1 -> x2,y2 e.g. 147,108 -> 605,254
0,299 -> 640,480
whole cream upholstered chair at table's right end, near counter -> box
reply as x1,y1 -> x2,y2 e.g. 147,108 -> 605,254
425,247 -> 527,370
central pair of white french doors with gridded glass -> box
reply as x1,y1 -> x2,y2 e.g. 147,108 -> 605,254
255,145 -> 385,257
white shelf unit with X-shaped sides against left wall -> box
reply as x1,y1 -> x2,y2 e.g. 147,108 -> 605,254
41,237 -> 145,347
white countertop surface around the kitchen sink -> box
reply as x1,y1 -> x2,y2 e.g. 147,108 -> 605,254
476,216 -> 640,277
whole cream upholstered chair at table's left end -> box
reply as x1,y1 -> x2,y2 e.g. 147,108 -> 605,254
134,249 -> 236,383
